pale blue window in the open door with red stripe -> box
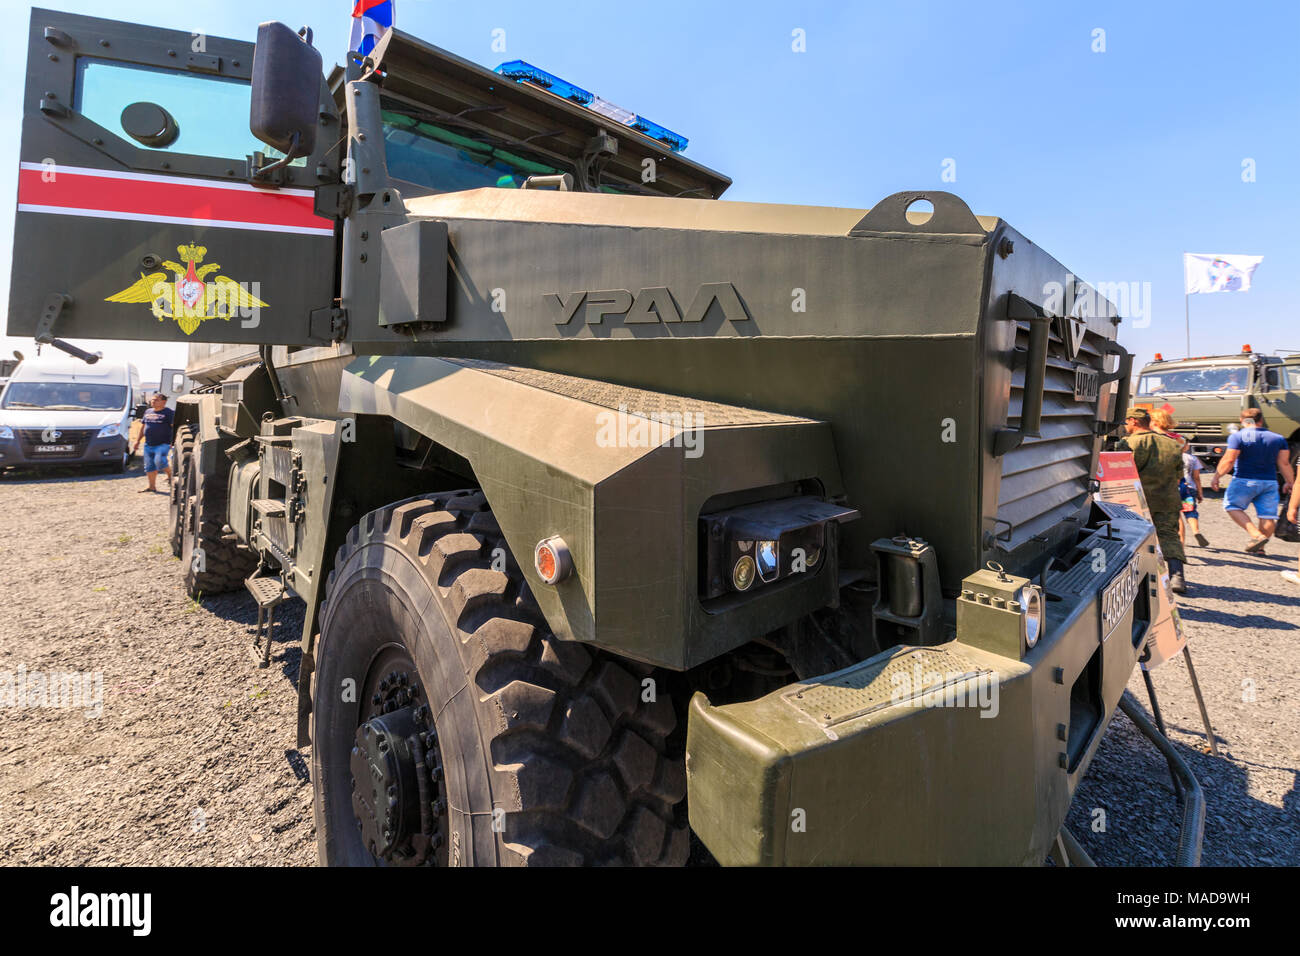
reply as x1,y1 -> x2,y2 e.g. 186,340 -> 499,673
74,56 -> 307,166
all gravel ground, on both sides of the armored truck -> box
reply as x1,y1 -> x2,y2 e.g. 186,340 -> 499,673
0,466 -> 1300,866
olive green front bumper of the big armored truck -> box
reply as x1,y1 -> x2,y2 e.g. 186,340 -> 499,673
686,519 -> 1161,865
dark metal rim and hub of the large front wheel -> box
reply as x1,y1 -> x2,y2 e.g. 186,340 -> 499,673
350,671 -> 443,865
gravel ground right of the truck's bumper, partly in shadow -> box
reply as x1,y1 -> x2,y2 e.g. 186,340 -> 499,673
1067,489 -> 1300,866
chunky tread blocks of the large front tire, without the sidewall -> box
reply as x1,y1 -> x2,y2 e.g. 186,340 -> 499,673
321,490 -> 690,865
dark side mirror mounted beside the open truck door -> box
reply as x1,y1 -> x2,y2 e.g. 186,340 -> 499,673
248,21 -> 321,160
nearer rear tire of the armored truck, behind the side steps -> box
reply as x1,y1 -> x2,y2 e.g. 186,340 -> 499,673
181,454 -> 257,598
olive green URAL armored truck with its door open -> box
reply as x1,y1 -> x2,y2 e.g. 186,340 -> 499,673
9,10 -> 1190,865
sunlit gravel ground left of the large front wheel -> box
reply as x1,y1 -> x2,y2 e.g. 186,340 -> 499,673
0,462 -> 316,866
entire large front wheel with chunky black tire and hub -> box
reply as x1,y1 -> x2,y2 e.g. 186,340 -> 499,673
312,490 -> 689,865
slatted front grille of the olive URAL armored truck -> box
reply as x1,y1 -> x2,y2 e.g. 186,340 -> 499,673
997,321 -> 1104,550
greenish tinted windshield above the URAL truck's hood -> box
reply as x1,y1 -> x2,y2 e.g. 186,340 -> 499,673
384,109 -> 567,193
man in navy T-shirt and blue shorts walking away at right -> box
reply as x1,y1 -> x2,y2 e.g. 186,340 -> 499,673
1210,408 -> 1295,554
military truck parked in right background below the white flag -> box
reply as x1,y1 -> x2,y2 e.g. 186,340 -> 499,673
1134,345 -> 1300,463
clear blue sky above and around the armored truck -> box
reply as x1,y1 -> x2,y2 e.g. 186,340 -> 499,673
0,0 -> 1300,377
